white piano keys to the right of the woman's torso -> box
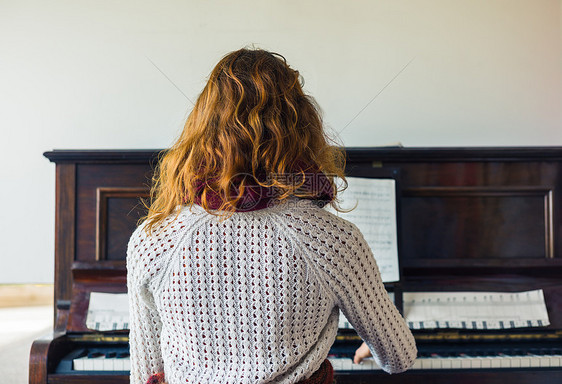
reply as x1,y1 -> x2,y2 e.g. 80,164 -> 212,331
328,349 -> 562,371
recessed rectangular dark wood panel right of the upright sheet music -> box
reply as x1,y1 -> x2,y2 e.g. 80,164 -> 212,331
401,187 -> 554,264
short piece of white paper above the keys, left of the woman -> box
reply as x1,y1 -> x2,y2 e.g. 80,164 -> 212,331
86,292 -> 129,331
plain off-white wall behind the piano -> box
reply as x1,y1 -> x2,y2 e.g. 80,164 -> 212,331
0,0 -> 562,283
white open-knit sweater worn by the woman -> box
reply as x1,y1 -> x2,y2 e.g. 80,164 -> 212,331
127,199 -> 417,384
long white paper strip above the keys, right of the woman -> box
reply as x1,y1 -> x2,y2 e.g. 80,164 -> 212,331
404,289 -> 550,329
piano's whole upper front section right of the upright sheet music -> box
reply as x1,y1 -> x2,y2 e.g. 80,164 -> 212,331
373,159 -> 562,275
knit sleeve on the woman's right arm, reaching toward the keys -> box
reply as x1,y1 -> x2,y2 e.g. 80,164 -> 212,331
296,208 -> 417,373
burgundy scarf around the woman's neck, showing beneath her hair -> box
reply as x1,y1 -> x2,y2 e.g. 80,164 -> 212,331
195,171 -> 334,212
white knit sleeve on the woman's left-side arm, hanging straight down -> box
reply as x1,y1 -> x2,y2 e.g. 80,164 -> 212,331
127,228 -> 164,384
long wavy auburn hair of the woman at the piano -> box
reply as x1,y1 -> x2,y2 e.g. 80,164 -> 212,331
145,49 -> 345,232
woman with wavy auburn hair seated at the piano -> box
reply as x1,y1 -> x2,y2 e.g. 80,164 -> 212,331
127,49 -> 416,384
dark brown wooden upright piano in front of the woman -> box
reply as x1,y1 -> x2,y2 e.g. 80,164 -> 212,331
29,147 -> 562,384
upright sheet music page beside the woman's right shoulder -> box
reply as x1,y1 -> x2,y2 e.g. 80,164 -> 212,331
331,177 -> 400,282
